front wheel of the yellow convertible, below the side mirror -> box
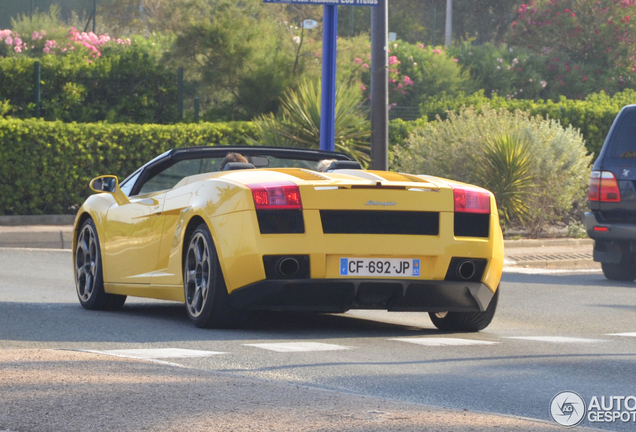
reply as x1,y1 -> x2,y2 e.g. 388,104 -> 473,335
74,219 -> 126,310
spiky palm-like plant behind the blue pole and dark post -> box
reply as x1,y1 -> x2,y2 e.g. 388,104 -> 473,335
255,80 -> 371,164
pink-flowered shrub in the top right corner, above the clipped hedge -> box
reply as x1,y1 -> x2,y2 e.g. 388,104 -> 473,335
502,0 -> 636,99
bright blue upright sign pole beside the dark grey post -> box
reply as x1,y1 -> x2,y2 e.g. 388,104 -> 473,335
320,5 -> 338,151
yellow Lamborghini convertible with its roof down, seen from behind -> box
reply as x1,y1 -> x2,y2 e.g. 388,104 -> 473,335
73,146 -> 503,331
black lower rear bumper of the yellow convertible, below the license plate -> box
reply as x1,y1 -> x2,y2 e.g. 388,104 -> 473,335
230,279 -> 493,313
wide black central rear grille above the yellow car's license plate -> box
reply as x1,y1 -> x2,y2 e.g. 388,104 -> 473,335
320,210 -> 439,235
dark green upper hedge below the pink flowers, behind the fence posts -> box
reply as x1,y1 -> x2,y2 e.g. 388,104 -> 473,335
0,47 -> 178,124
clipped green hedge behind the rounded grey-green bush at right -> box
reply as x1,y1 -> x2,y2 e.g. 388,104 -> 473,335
421,90 -> 636,156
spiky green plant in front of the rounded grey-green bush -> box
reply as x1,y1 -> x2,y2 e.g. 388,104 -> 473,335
478,135 -> 535,222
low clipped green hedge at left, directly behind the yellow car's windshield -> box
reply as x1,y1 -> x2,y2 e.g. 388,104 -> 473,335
0,119 -> 255,215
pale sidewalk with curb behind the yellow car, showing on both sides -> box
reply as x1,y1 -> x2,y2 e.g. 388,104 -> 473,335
0,216 -> 600,269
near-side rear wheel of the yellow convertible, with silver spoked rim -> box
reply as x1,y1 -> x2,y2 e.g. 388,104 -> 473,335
183,224 -> 235,328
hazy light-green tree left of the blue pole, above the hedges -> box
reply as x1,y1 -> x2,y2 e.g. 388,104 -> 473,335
169,0 -> 303,120
